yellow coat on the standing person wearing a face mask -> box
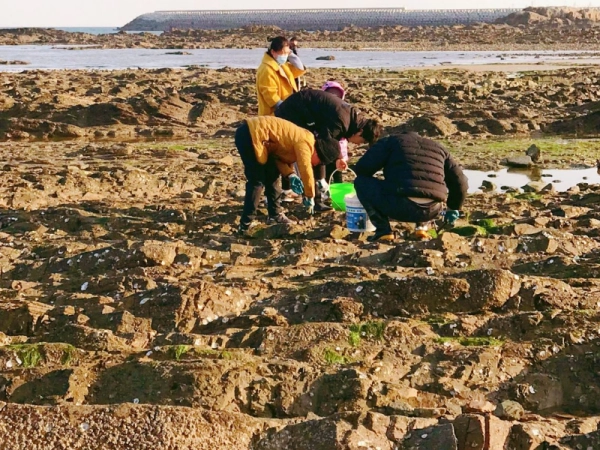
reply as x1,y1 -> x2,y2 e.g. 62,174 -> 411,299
256,53 -> 306,116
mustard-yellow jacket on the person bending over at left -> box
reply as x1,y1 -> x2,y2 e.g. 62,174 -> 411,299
246,116 -> 315,198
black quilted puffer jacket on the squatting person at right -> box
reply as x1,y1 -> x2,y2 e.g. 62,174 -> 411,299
354,132 -> 468,209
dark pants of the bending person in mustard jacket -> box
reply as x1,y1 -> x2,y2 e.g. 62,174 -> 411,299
235,122 -> 281,226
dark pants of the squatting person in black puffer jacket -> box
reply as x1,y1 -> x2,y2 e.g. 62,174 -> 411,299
354,176 -> 443,232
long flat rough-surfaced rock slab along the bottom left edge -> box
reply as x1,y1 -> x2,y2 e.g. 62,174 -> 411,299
0,402 -> 260,450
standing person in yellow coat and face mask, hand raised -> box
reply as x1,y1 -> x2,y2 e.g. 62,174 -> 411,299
256,36 -> 306,116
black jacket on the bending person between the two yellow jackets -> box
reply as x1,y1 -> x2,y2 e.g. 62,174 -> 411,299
275,89 -> 367,141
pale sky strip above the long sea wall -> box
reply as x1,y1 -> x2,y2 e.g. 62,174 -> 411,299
0,0 -> 600,28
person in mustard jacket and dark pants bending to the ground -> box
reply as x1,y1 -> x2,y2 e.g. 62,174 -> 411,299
235,116 -> 341,233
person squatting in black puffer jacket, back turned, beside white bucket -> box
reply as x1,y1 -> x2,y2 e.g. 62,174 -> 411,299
354,132 -> 468,242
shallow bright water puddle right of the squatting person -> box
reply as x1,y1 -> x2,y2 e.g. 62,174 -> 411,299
464,167 -> 600,193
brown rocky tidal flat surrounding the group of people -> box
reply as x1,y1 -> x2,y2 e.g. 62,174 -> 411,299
0,60 -> 600,450
